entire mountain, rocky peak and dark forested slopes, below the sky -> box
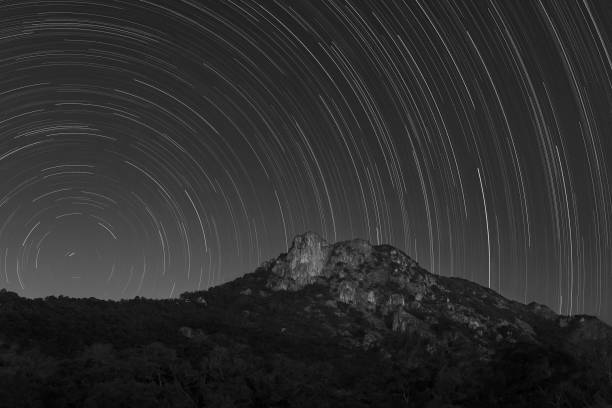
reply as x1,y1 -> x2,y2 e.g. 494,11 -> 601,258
0,233 -> 612,408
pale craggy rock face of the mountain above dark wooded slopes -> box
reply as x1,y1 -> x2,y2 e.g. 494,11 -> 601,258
250,232 -> 611,355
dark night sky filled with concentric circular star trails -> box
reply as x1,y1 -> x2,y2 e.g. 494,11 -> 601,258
0,0 -> 612,321
